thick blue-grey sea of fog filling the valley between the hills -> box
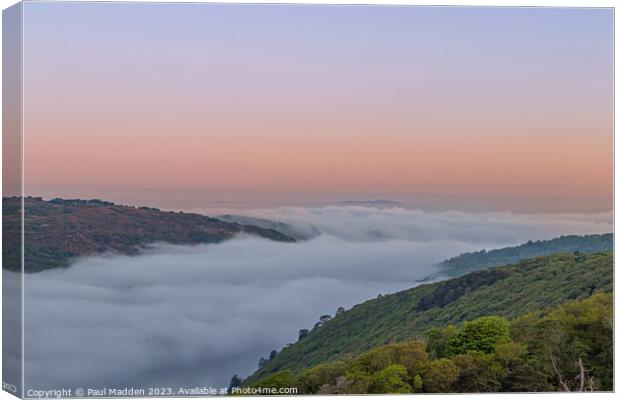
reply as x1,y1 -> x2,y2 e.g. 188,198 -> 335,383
13,207 -> 612,389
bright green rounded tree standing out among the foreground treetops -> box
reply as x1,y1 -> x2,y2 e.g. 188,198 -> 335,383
446,317 -> 510,356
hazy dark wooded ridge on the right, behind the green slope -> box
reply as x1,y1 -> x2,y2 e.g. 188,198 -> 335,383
437,233 -> 614,277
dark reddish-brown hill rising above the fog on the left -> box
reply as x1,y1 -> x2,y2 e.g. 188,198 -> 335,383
2,197 -> 295,272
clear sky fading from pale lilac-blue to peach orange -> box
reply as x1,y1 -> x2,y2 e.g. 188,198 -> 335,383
24,3 -> 613,211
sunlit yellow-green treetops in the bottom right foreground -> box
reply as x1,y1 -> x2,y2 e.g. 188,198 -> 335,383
245,292 -> 613,394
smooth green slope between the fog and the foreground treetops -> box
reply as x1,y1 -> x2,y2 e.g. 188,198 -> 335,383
246,252 -> 613,384
